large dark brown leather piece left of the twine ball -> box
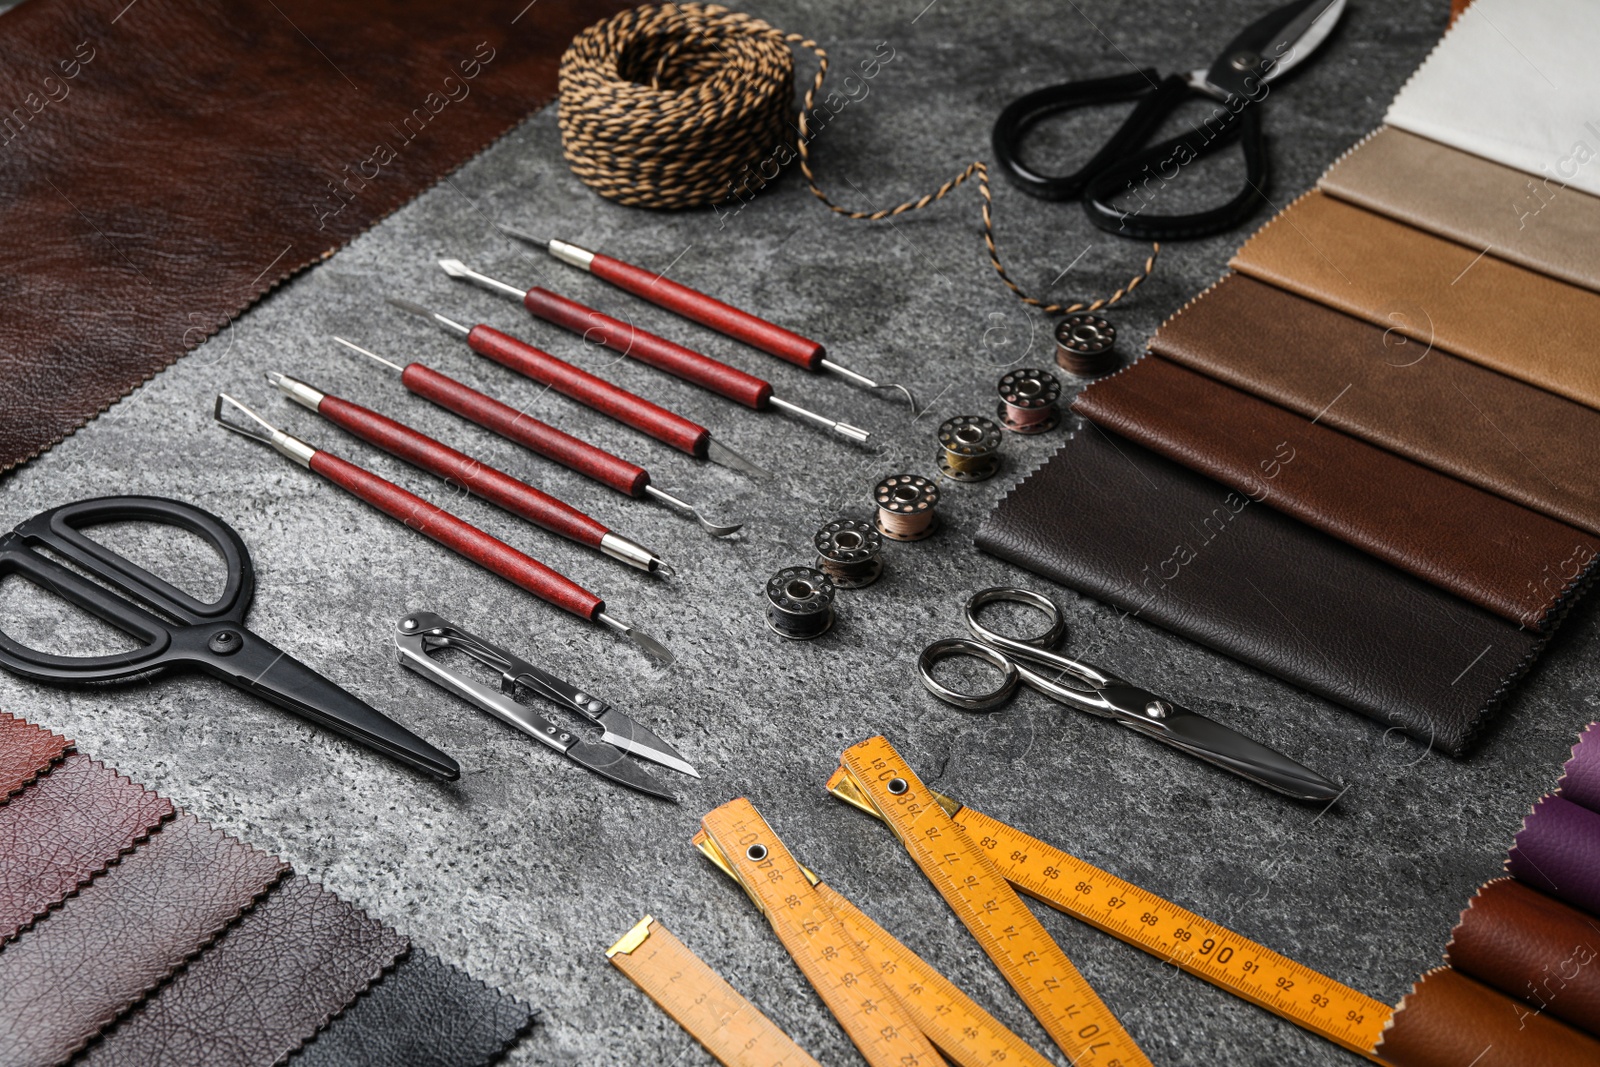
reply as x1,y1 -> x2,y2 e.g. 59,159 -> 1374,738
0,0 -> 627,470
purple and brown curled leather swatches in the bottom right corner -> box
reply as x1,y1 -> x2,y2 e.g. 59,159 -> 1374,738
1378,725 -> 1600,1067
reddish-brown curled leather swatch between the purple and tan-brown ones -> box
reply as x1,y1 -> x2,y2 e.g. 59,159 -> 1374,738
1445,878 -> 1600,1037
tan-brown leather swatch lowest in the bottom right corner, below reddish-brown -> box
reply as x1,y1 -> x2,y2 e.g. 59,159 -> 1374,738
1376,968 -> 1600,1067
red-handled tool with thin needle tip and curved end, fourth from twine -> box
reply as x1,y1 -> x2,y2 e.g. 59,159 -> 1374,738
334,338 -> 744,537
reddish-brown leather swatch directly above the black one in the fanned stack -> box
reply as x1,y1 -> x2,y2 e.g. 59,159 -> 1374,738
1072,355 -> 1600,630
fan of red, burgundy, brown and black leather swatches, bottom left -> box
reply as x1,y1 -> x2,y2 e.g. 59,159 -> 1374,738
0,712 -> 533,1067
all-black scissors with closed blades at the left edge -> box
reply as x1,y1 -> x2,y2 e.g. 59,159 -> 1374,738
0,496 -> 461,779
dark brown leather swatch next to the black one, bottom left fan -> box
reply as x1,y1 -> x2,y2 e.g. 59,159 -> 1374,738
82,875 -> 408,1067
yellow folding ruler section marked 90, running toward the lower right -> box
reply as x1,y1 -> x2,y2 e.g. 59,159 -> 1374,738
827,737 -> 1392,1056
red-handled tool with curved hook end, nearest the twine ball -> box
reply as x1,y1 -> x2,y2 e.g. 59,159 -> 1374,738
499,226 -> 917,414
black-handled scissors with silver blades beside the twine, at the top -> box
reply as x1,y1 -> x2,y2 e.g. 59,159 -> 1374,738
994,0 -> 1346,242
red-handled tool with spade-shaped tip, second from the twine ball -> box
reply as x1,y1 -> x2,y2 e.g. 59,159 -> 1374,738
438,259 -> 872,445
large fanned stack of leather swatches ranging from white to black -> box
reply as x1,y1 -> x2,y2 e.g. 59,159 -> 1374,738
978,0 -> 1600,755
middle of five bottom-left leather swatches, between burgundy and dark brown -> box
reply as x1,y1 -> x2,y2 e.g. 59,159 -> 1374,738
0,814 -> 288,1067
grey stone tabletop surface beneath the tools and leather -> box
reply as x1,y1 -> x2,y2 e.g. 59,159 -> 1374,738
0,0 -> 1600,1065
